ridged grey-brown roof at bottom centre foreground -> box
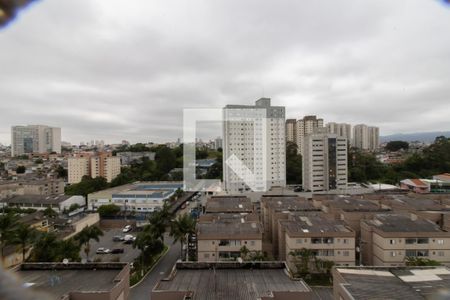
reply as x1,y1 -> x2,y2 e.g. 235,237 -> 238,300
154,269 -> 310,300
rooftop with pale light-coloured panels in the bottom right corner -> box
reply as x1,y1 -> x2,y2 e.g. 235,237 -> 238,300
335,267 -> 450,300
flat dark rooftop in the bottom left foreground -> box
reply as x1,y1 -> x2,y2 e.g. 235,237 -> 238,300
16,263 -> 126,299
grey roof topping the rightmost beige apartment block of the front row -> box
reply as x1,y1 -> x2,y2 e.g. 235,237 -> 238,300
363,214 -> 442,232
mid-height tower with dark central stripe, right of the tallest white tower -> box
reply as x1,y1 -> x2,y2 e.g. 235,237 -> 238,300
303,133 -> 348,192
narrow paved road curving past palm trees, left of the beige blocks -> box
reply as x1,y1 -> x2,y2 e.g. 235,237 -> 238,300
130,235 -> 180,300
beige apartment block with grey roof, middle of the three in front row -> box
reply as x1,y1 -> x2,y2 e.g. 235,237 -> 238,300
279,213 -> 356,269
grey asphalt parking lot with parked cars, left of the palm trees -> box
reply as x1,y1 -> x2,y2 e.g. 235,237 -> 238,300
80,228 -> 140,262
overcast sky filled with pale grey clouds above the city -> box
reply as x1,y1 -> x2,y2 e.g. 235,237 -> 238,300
0,0 -> 450,144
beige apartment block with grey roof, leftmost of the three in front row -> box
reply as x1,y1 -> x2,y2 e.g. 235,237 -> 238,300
197,214 -> 263,262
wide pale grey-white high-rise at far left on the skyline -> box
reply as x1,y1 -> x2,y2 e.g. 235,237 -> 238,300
11,125 -> 61,156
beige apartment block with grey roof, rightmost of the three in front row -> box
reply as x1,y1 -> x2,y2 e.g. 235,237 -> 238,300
361,214 -> 450,266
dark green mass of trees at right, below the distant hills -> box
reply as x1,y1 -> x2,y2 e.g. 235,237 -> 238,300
348,137 -> 450,184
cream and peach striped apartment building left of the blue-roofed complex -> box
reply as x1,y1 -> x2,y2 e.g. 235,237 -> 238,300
68,152 -> 120,184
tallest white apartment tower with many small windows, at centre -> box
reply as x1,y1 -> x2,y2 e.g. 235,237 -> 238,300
223,98 -> 286,193
